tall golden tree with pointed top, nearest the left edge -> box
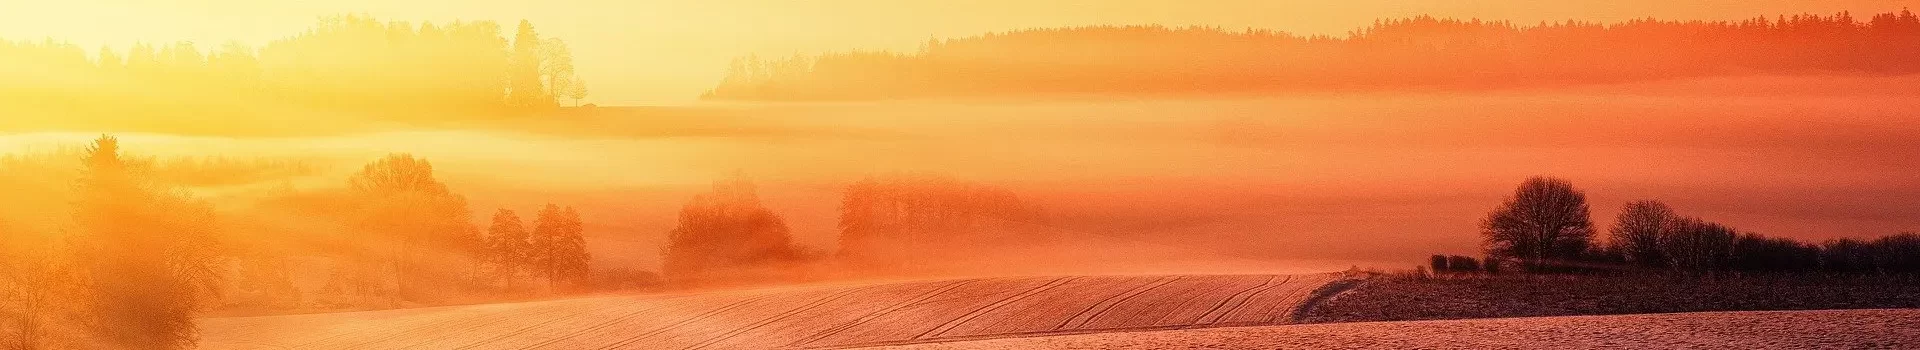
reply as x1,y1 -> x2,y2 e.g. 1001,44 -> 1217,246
73,137 -> 219,348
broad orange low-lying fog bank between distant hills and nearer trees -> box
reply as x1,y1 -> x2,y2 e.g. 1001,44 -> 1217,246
0,92 -> 1920,271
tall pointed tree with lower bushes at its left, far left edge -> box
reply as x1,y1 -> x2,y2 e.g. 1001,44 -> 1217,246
0,137 -> 227,350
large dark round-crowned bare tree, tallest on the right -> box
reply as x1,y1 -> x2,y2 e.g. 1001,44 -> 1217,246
1480,177 -> 1594,271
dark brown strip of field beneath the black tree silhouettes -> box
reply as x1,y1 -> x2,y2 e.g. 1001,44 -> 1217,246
1300,275 -> 1920,323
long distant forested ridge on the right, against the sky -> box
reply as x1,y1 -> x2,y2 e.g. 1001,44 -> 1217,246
705,10 -> 1920,100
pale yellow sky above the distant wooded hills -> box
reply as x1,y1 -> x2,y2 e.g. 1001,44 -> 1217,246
0,0 -> 1920,104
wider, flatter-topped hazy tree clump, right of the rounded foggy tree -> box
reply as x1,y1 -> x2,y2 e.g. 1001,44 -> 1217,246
839,175 -> 1041,263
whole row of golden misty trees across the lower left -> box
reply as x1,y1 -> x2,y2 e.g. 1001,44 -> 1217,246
0,137 -> 595,350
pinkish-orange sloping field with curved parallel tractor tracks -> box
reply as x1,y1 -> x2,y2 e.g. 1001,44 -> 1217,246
191,273 -> 1340,348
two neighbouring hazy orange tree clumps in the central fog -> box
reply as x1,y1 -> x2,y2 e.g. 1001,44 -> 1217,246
662,175 -> 1041,281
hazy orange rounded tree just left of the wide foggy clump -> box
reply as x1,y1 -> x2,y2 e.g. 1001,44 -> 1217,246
664,179 -> 801,279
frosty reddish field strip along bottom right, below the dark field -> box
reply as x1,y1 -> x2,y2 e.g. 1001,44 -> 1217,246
887,310 -> 1920,350
